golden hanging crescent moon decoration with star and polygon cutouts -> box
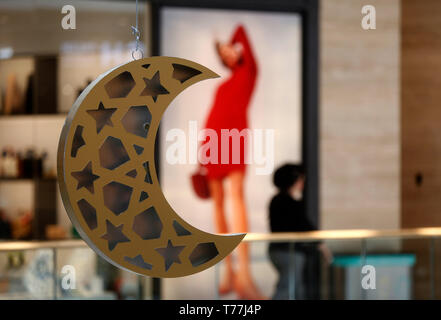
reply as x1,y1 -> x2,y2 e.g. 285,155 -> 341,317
57,57 -> 245,278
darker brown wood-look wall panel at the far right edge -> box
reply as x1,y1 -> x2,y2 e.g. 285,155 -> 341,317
401,0 -> 441,228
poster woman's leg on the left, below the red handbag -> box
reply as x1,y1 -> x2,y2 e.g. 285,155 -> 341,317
208,179 -> 234,294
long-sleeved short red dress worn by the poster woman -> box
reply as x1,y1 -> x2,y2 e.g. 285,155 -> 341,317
202,26 -> 257,179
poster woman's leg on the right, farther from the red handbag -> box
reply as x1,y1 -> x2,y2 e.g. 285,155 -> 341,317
228,171 -> 263,299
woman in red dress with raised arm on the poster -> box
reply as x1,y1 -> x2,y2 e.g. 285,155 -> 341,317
202,26 -> 263,299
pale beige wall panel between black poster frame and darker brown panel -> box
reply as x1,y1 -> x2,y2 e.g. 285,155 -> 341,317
320,0 -> 400,229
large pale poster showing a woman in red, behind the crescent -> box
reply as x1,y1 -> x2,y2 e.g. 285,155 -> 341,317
152,1 -> 318,299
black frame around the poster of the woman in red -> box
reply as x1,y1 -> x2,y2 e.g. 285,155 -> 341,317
149,0 -> 320,299
